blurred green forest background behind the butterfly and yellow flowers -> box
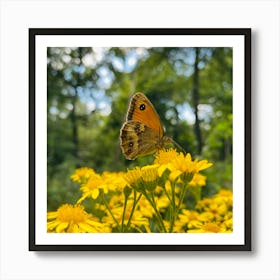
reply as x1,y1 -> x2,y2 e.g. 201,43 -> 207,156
47,47 -> 232,210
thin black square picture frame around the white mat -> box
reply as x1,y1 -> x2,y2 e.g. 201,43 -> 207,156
29,28 -> 252,251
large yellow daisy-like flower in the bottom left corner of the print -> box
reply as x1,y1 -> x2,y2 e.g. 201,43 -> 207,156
47,204 -> 108,233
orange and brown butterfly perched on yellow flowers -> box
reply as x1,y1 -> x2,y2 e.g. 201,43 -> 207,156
120,92 -> 184,160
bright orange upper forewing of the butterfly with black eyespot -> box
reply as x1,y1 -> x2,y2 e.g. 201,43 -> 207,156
126,92 -> 163,137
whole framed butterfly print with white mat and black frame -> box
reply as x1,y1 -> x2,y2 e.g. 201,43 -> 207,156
29,28 -> 251,251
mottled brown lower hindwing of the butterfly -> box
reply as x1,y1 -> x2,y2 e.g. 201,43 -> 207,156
120,120 -> 162,160
